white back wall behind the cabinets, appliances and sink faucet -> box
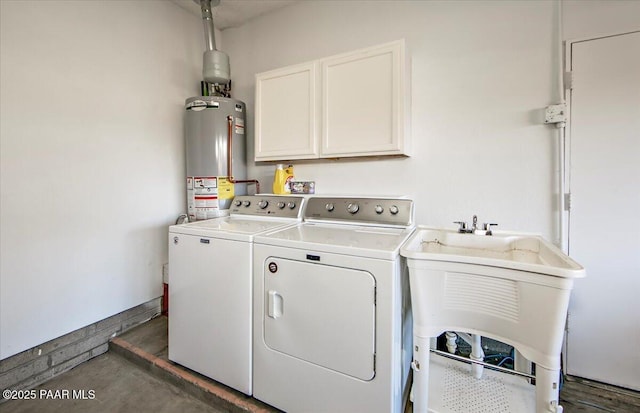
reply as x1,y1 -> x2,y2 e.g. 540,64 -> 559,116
222,1 -> 558,239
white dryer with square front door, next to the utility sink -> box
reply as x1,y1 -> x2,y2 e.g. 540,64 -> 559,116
253,197 -> 414,413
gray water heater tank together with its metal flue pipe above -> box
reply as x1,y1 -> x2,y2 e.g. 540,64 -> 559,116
185,0 -> 260,221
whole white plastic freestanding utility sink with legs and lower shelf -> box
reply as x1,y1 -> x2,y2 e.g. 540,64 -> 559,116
400,226 -> 585,413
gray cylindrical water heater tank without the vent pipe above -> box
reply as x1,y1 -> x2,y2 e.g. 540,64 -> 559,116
185,96 -> 247,221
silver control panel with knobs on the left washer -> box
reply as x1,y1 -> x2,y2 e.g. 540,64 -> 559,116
230,195 -> 305,218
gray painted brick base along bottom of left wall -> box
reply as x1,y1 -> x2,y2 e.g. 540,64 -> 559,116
0,298 -> 162,402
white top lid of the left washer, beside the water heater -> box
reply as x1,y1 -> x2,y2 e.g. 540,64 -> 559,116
169,216 -> 299,242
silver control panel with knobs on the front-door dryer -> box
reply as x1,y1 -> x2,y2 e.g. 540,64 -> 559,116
304,197 -> 413,227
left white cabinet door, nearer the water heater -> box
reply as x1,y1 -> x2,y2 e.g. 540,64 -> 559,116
255,63 -> 318,161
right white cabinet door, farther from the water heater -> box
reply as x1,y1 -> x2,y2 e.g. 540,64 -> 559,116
320,41 -> 408,157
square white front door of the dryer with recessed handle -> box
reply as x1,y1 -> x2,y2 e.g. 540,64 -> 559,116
263,258 -> 376,380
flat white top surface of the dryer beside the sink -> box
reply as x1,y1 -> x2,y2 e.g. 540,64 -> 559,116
254,222 -> 414,260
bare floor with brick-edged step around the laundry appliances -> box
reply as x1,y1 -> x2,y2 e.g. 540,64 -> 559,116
0,317 -> 640,413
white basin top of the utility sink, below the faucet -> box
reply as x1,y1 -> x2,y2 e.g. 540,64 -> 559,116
401,227 -> 585,278
